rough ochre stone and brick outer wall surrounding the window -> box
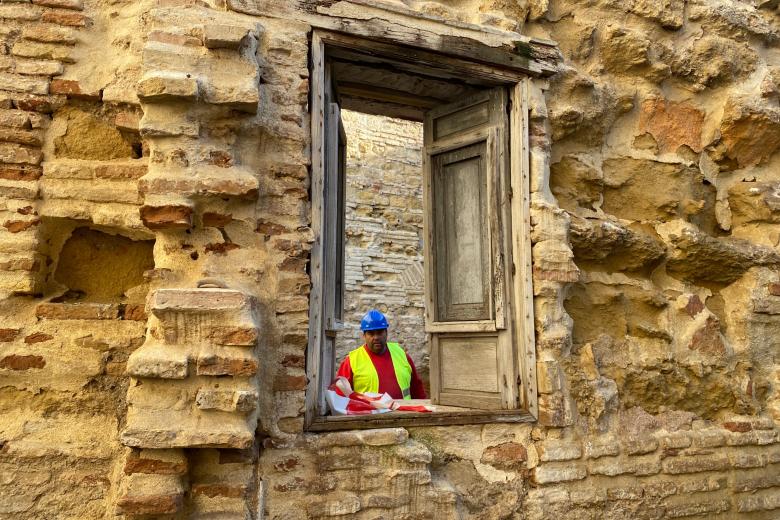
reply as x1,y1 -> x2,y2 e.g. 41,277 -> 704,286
0,0 -> 780,520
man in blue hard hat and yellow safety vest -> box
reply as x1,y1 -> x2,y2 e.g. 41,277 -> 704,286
336,309 -> 426,399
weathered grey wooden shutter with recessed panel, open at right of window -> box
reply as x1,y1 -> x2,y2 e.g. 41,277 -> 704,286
424,88 -> 519,409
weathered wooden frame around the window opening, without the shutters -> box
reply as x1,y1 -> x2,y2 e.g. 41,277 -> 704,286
304,29 -> 538,431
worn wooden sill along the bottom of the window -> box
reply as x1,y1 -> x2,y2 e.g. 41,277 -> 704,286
307,399 -> 536,432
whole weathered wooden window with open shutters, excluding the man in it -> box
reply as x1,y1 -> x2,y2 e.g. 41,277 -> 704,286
307,32 -> 536,429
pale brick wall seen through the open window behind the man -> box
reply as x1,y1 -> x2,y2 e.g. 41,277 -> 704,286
336,110 -> 429,392
